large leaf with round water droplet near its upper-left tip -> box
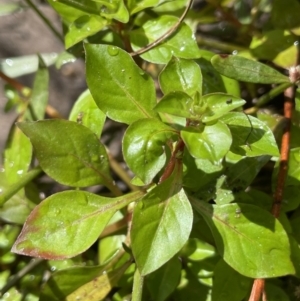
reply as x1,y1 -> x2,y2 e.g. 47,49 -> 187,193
85,44 -> 157,124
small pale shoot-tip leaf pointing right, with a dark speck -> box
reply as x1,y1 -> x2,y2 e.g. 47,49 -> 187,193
201,93 -> 246,123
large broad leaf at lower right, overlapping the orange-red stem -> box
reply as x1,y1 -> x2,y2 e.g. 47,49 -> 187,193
191,199 -> 295,278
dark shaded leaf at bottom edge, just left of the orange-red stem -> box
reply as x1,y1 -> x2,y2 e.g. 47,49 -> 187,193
211,260 -> 252,301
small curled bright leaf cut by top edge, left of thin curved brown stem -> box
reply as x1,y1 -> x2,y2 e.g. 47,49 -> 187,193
93,0 -> 129,23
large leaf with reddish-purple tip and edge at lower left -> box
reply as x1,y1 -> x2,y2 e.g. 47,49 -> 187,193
12,190 -> 143,259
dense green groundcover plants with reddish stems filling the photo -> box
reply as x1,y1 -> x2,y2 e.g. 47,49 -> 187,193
0,0 -> 300,301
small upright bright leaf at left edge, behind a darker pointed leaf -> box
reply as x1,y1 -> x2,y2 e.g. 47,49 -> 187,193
4,125 -> 32,184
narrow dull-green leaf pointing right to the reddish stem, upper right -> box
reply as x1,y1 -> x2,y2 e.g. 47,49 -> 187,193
211,54 -> 290,84
